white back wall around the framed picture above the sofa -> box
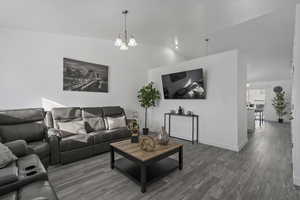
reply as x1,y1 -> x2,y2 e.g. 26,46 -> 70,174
0,29 -> 182,117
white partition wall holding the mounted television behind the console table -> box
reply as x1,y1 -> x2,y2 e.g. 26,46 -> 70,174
148,50 -> 247,151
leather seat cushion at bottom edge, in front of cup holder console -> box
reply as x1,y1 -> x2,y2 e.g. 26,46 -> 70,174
18,181 -> 58,200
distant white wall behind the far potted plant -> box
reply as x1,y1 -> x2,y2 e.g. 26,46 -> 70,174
249,80 -> 292,122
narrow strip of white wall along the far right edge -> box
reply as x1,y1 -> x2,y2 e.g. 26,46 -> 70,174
292,4 -> 300,186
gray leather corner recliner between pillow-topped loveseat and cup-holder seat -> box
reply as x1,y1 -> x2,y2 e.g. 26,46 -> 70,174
0,108 -> 57,168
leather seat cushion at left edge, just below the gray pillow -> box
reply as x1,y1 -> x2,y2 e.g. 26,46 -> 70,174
0,162 -> 18,186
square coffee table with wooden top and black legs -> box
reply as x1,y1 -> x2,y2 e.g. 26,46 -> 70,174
110,140 -> 183,193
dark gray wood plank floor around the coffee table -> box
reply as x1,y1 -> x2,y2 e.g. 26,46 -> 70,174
49,123 -> 300,200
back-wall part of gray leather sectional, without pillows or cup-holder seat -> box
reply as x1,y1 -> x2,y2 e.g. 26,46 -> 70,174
0,106 -> 131,165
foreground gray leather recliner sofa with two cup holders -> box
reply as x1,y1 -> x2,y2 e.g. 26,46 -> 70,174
0,140 -> 58,200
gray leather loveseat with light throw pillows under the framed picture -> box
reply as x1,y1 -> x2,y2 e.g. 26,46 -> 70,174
47,106 -> 131,164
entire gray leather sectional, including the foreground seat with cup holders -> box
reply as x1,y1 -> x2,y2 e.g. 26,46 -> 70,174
0,106 -> 131,200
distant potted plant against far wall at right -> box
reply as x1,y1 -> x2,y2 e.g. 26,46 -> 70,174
272,86 -> 287,123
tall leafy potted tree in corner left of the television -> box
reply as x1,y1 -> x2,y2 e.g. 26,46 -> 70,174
137,82 -> 160,135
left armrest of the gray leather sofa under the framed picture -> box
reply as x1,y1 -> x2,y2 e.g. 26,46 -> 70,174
47,128 -> 61,165
